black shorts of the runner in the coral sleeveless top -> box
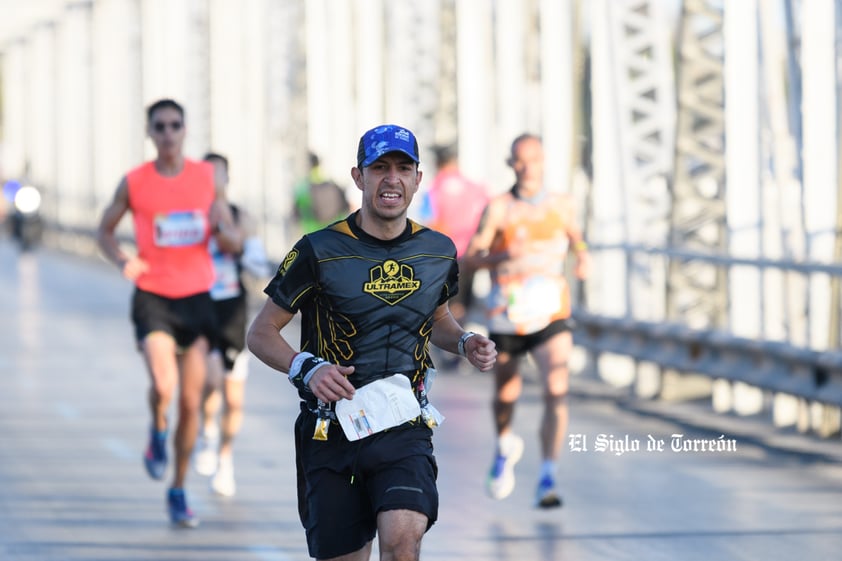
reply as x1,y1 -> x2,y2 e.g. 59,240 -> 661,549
132,288 -> 216,349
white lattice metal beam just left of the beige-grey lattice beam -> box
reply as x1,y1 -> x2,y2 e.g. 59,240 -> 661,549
607,0 -> 676,319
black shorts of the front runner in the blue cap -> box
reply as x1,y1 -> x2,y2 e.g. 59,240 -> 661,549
295,403 -> 439,559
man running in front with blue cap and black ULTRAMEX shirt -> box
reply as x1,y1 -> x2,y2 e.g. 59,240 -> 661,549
248,125 -> 497,561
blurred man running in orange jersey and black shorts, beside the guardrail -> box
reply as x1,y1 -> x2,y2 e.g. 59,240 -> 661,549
466,134 -> 588,508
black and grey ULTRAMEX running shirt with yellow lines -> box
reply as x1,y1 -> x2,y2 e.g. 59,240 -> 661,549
264,214 -> 459,399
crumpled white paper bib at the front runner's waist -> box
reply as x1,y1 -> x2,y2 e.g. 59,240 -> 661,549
336,374 -> 421,441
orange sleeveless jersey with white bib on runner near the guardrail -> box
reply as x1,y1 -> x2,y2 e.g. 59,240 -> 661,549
486,192 -> 570,335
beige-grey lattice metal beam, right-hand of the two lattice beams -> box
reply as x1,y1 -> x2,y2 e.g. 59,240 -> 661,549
667,0 -> 727,328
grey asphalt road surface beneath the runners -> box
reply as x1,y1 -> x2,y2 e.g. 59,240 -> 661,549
0,239 -> 842,561
